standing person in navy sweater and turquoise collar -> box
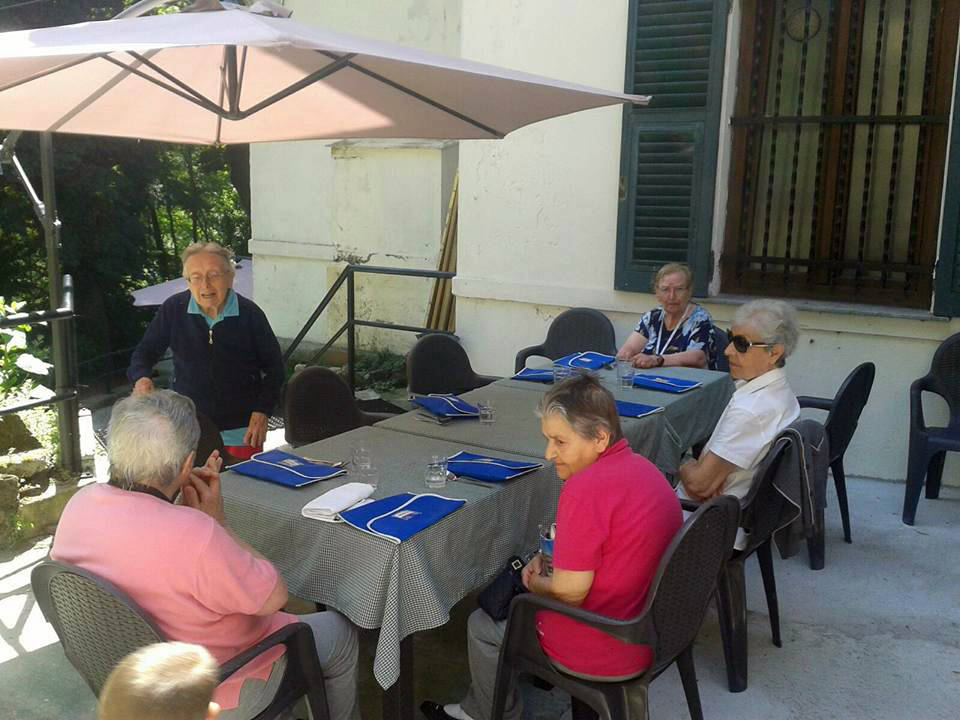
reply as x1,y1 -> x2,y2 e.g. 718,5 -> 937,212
127,243 -> 284,457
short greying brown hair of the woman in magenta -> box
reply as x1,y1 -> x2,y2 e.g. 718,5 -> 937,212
536,375 -> 623,447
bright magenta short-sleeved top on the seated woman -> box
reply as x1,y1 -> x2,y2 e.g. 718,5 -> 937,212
538,440 -> 683,677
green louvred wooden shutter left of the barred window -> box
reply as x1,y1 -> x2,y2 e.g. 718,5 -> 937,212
615,0 -> 729,295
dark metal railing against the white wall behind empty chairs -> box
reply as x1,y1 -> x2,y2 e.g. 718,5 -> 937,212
283,265 -> 456,390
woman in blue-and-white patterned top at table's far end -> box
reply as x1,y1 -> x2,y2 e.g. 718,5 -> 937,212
617,263 -> 713,368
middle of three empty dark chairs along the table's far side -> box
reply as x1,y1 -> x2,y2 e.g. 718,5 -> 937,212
407,333 -> 499,395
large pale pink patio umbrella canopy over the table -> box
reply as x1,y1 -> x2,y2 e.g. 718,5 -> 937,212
0,6 -> 649,144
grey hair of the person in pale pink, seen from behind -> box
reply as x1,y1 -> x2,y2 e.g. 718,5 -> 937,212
107,390 -> 200,488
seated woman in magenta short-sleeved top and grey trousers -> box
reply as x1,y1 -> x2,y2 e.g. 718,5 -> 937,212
421,376 -> 683,720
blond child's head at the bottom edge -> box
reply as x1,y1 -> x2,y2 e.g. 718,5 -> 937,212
97,642 -> 220,720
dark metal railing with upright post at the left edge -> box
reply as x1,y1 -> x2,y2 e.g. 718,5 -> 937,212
0,275 -> 81,473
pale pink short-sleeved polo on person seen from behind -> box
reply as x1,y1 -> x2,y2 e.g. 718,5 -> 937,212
50,484 -> 296,708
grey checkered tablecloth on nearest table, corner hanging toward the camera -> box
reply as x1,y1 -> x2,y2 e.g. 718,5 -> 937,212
222,428 -> 560,688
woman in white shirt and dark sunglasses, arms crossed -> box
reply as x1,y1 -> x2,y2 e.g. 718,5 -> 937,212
677,300 -> 800,501
